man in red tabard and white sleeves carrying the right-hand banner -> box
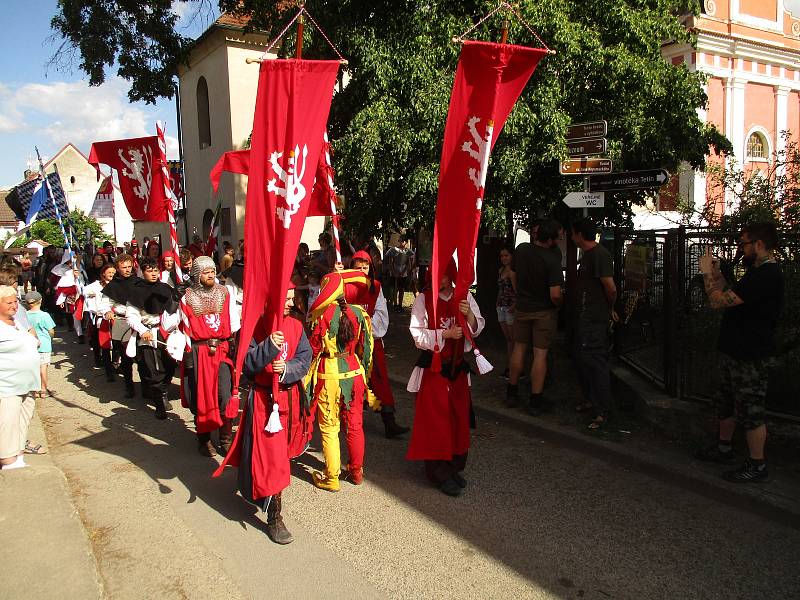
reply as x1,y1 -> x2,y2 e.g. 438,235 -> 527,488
406,259 -> 486,496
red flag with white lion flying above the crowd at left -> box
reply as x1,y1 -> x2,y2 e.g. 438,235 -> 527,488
89,136 -> 167,221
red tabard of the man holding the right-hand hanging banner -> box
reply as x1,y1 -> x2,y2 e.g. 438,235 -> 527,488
406,292 -> 471,460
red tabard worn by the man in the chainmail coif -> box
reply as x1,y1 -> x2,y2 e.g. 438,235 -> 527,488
181,295 -> 233,433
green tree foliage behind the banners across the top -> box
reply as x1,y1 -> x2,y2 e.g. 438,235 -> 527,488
54,0 -> 730,231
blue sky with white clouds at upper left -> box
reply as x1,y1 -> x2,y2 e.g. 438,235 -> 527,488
0,0 -> 216,189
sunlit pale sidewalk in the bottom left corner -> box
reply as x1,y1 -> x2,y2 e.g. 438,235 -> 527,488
0,400 -> 104,599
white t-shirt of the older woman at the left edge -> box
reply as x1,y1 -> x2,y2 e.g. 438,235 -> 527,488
0,321 -> 42,398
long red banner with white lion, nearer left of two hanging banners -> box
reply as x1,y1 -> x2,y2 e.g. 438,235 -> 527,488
236,59 -> 339,404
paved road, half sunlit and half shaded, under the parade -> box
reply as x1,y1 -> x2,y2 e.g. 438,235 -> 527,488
25,324 -> 800,600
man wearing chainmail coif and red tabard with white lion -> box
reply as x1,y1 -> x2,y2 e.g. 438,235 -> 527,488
181,256 -> 240,457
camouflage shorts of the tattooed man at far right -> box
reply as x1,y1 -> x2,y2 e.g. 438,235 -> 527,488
717,354 -> 769,430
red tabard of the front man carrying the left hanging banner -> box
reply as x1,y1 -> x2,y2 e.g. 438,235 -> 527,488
215,318 -> 306,498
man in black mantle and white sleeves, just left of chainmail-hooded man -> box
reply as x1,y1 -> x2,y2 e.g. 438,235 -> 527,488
126,256 -> 178,419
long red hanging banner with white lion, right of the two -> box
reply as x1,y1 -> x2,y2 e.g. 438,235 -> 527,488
431,41 -> 547,314
